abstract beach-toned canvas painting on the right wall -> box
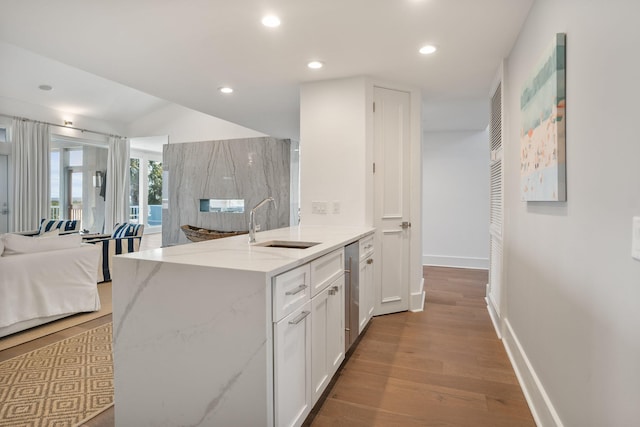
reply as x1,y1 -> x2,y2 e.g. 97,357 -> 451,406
520,33 -> 567,201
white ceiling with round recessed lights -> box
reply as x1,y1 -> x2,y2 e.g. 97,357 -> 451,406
0,0 -> 533,139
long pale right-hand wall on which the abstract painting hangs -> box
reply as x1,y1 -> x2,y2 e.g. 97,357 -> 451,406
504,0 -> 640,427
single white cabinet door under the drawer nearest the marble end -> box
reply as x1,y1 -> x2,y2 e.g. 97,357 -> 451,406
274,301 -> 312,427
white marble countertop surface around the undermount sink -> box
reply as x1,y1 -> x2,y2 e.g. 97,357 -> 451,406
118,226 -> 375,276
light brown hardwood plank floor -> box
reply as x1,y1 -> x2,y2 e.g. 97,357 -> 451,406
0,267 -> 535,427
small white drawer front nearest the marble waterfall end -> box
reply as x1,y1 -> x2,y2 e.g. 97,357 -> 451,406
273,264 -> 311,322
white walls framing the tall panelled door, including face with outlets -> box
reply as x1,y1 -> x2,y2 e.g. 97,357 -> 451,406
300,76 -> 424,310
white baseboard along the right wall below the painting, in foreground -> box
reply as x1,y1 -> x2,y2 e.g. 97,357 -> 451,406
502,319 -> 563,427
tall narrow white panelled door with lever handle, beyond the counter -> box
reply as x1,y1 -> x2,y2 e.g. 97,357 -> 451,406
374,87 -> 411,314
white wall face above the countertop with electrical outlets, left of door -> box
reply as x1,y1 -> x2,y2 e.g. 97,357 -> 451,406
300,77 -> 372,229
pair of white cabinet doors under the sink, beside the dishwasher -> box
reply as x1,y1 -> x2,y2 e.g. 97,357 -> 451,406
311,274 -> 345,405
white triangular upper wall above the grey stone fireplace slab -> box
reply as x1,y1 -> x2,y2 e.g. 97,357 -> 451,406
127,104 -> 267,146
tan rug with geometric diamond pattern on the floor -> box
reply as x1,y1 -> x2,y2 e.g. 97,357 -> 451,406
0,323 -> 113,427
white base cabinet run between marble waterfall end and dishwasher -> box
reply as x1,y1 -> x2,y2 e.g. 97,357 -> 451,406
272,248 -> 345,427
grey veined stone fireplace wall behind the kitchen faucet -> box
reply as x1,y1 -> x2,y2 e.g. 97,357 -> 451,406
162,137 -> 291,246
